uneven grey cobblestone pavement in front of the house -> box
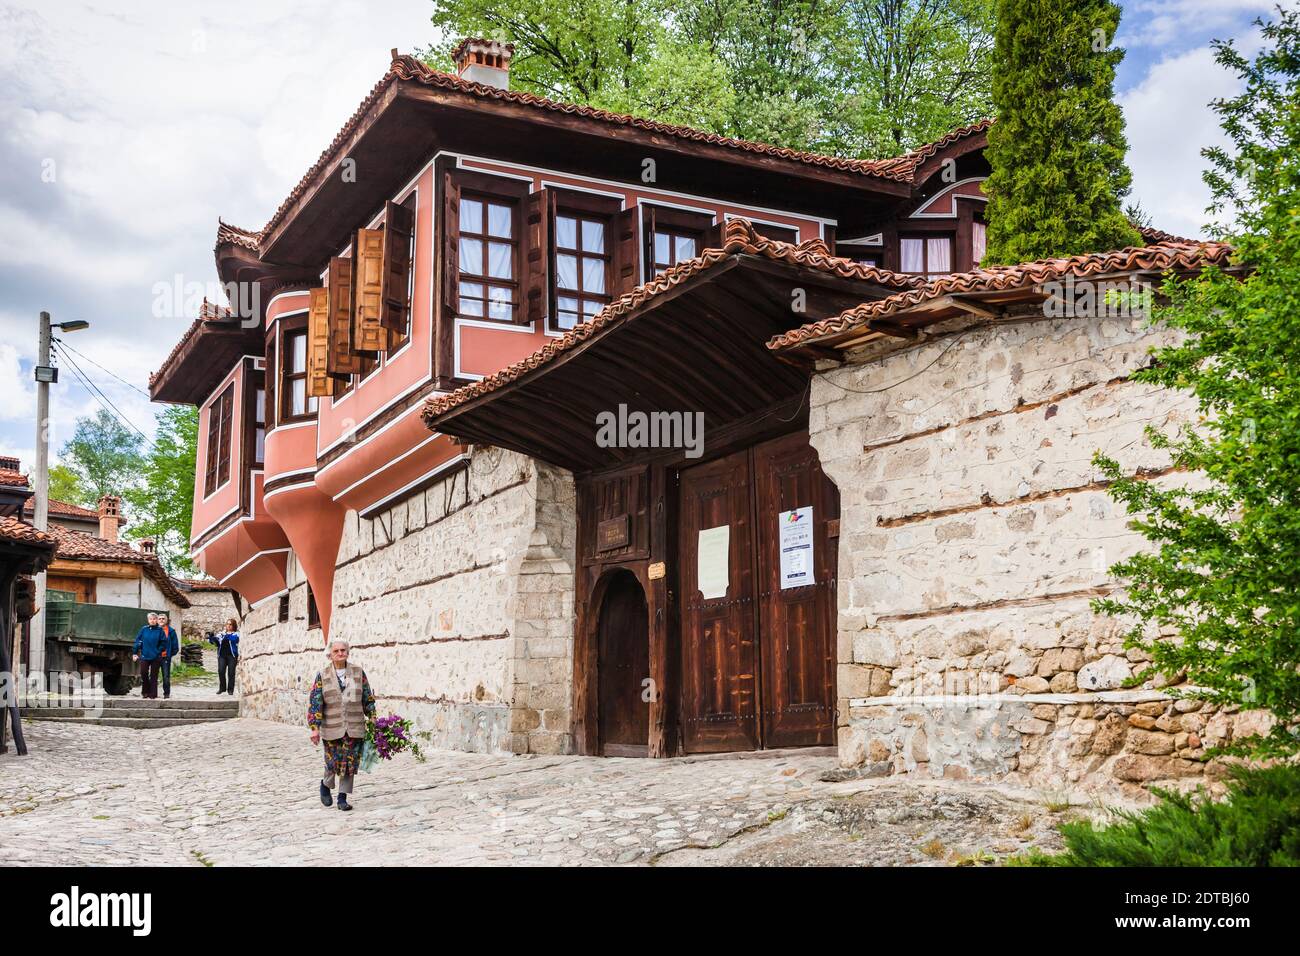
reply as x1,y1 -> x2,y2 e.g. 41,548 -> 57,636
0,718 -> 1062,866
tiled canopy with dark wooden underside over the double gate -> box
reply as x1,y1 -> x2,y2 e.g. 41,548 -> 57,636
424,220 -> 919,472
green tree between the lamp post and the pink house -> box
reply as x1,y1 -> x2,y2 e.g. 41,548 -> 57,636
126,405 -> 199,574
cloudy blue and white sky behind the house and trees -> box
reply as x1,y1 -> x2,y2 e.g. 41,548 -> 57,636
0,0 -> 1271,467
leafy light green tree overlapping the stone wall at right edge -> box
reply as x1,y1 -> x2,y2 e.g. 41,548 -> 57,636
1097,10 -> 1300,753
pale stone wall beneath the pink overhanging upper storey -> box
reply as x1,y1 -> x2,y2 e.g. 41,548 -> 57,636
241,449 -> 576,753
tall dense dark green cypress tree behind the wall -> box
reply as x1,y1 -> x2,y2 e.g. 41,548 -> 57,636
983,0 -> 1141,264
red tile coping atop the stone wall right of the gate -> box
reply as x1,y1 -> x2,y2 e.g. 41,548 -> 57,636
767,242 -> 1232,351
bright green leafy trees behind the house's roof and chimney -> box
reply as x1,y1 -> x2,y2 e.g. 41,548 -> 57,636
425,0 -> 992,156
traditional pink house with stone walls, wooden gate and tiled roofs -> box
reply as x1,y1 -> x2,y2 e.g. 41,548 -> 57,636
151,40 -> 1227,783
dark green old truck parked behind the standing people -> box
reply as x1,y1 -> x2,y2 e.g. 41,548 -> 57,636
46,591 -> 159,695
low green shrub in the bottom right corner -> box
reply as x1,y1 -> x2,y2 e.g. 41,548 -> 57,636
1014,765 -> 1300,866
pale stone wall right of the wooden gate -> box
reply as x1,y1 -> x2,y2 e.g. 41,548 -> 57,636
810,315 -> 1260,793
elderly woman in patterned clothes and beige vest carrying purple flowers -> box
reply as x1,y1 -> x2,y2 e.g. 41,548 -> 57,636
307,637 -> 374,810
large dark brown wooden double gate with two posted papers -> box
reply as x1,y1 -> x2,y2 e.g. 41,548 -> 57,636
679,433 -> 839,753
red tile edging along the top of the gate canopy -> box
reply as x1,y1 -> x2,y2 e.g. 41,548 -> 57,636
421,219 -> 923,424
